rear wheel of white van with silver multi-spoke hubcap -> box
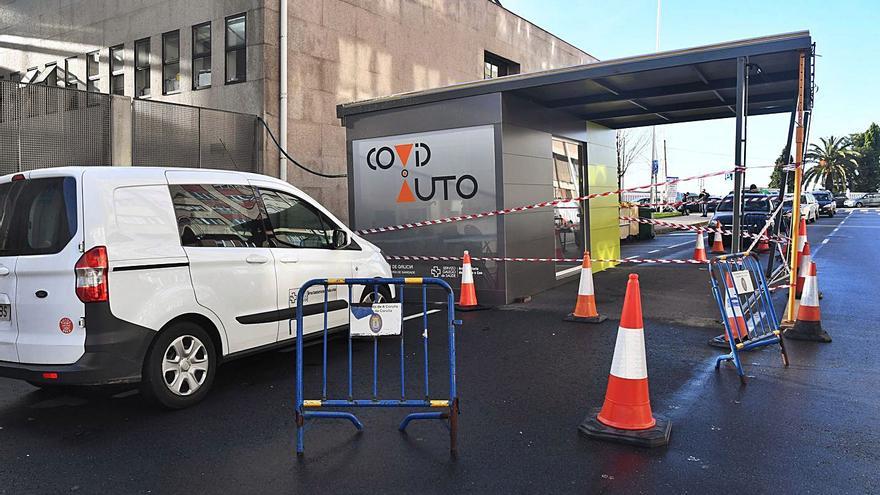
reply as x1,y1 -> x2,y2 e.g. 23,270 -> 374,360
141,322 -> 217,409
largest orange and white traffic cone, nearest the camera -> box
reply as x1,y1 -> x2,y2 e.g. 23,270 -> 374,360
578,274 -> 672,447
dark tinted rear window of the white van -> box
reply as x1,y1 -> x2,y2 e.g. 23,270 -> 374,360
0,177 -> 77,256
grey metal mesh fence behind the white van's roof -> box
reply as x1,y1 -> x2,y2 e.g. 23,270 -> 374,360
0,81 -> 263,175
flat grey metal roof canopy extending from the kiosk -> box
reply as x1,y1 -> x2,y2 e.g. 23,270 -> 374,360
336,31 -> 812,129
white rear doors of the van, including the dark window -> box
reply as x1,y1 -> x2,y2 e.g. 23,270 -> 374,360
0,170 -> 85,364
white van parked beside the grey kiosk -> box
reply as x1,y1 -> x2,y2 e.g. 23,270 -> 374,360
0,167 -> 394,408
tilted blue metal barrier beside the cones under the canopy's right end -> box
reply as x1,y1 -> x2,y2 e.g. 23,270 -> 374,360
709,253 -> 788,383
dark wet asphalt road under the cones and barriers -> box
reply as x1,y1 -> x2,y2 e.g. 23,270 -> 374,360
0,210 -> 880,494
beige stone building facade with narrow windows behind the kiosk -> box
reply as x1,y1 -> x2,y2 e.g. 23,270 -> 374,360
0,0 -> 596,218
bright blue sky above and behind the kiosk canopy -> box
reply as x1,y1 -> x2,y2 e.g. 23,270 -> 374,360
501,0 -> 880,194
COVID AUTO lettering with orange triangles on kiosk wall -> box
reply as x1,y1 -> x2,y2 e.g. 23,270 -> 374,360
366,142 -> 479,203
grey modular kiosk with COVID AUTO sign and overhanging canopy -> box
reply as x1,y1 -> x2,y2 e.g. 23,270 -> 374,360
337,32 -> 812,304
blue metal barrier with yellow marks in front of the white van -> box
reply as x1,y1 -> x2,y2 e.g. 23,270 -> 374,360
295,277 -> 461,455
